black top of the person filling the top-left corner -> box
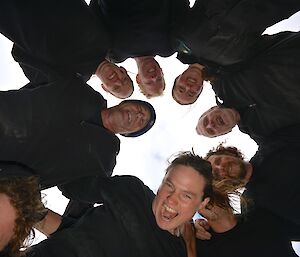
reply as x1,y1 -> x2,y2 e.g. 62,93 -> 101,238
0,0 -> 110,83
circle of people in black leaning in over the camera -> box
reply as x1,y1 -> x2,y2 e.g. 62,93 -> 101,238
0,0 -> 300,257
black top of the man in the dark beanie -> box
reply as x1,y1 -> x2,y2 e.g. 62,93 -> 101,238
0,75 -> 120,190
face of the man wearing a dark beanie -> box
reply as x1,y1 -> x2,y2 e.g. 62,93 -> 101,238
109,102 -> 150,134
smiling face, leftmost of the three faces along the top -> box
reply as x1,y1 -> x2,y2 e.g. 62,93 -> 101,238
97,62 -> 133,99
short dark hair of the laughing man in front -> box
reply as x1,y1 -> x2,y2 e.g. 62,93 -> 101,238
167,151 -> 213,198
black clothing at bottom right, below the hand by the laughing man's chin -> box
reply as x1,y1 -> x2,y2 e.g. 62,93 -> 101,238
196,210 -> 298,257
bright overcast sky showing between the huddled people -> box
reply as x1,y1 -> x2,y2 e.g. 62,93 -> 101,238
0,4 -> 300,254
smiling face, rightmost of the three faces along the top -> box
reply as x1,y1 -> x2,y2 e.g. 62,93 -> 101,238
173,66 -> 203,104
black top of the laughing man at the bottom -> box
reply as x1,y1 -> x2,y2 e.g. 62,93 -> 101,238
27,176 -> 186,257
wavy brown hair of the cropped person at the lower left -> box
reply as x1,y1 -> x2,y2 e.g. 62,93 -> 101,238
0,176 -> 47,257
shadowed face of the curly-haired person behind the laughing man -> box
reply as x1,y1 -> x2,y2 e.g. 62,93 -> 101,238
208,155 -> 247,180
